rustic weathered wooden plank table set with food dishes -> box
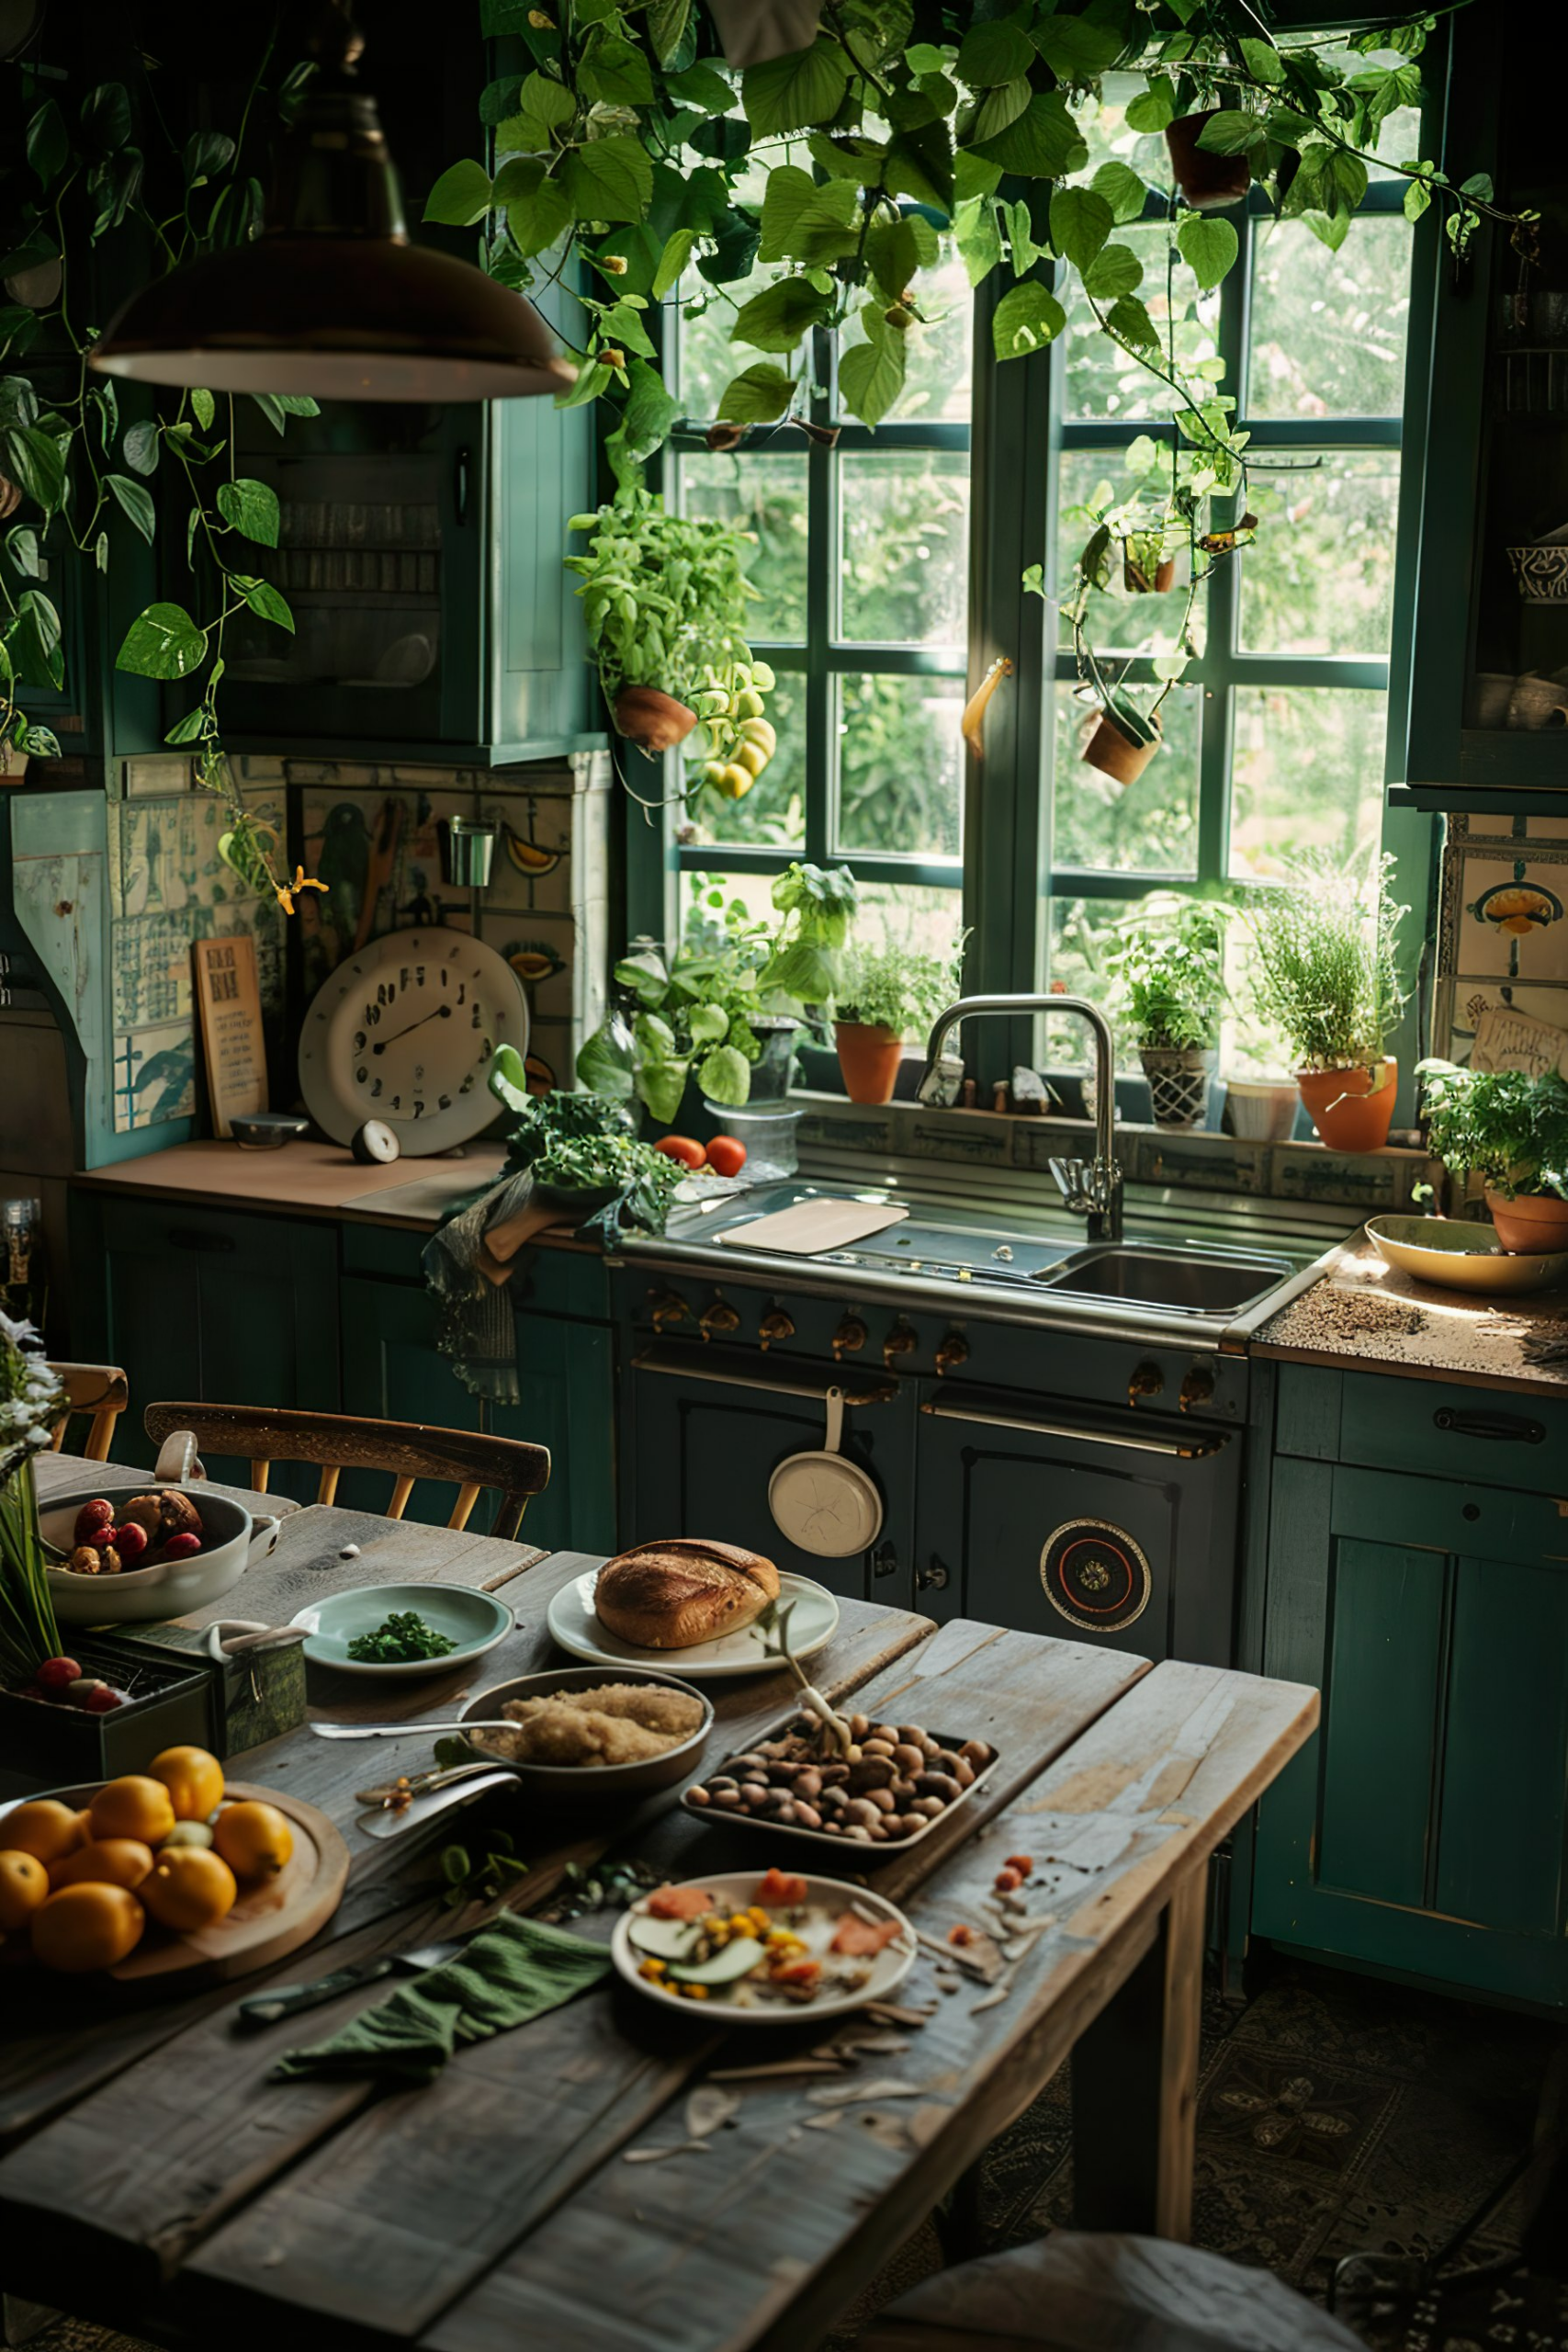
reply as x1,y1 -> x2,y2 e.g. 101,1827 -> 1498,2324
0,1508 -> 1316,2352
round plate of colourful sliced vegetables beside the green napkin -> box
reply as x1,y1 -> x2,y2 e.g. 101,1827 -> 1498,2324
611,1870 -> 917,2025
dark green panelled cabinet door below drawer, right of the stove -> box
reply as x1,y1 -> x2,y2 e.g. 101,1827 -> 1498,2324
1253,1458 -> 1568,2004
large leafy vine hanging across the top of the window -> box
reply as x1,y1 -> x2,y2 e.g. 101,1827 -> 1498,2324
439,0 -> 1535,799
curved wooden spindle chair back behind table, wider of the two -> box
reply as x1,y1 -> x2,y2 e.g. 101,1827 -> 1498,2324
141,1404 -> 550,1538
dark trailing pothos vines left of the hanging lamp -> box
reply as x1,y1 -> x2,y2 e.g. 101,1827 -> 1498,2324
0,48 -> 322,912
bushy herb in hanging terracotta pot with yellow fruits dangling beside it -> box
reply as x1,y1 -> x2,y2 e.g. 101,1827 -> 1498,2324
564,487 -> 773,762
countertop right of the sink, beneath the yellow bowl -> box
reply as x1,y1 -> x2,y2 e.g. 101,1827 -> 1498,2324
1253,1232 -> 1568,1395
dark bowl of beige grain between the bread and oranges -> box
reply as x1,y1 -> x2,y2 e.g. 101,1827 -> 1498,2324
463,1665 -> 712,1802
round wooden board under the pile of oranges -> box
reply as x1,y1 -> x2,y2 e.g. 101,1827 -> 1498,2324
0,1781 -> 348,1995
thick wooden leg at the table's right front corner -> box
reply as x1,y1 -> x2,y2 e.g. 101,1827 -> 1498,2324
1072,1858 -> 1208,2244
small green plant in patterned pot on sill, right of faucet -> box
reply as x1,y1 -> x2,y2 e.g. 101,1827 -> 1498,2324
1107,899 -> 1224,1129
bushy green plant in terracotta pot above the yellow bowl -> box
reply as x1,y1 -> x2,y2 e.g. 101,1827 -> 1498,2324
1416,1061 -> 1568,1251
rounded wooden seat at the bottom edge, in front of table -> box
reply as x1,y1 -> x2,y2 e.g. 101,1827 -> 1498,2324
858,2230 -> 1363,2352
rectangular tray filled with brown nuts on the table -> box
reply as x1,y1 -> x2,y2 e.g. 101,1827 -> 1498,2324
682,1713 -> 997,1860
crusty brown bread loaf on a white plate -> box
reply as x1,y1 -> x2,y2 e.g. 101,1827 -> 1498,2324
550,1536 -> 840,1681
